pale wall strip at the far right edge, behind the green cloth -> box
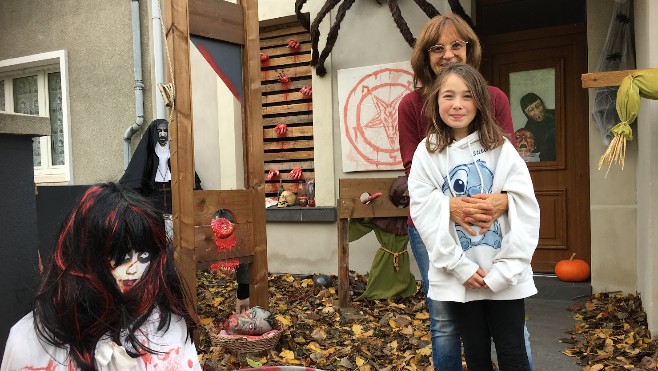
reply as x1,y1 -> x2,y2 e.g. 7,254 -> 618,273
627,0 -> 658,334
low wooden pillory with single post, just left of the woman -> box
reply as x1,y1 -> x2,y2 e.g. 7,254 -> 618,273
337,178 -> 409,308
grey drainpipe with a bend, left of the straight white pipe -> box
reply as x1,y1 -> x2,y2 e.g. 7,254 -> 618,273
123,0 -> 144,169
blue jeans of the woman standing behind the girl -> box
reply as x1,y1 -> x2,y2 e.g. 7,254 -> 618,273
409,227 -> 533,371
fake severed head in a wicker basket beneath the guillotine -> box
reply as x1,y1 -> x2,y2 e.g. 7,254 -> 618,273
211,307 -> 281,353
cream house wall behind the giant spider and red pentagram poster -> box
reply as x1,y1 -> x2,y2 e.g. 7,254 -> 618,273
259,0 -> 470,277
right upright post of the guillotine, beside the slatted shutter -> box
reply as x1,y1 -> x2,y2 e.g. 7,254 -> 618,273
240,0 -> 269,308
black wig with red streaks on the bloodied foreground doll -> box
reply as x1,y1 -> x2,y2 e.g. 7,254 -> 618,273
34,183 -> 197,370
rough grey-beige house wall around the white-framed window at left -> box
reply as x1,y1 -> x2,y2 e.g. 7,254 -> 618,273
0,0 -> 153,184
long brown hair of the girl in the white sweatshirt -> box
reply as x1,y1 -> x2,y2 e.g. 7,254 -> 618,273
423,63 -> 505,153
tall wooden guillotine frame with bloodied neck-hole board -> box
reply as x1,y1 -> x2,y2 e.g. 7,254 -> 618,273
164,0 -> 269,309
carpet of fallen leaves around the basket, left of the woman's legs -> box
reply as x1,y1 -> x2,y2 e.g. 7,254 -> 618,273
197,271 -> 432,371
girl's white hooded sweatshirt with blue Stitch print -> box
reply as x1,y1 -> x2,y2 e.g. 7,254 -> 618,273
409,132 -> 539,303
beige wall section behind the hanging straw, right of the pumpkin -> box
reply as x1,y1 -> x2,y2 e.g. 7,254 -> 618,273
587,0 -> 638,292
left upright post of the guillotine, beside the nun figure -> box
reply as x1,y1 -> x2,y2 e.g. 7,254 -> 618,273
165,0 -> 197,310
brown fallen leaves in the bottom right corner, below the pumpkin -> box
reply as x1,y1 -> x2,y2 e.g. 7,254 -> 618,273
560,293 -> 658,371
